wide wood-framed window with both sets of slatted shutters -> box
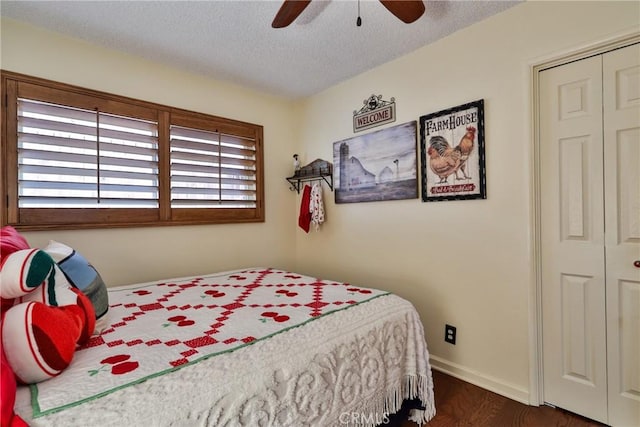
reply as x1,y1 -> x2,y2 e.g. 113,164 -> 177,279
0,72 -> 264,229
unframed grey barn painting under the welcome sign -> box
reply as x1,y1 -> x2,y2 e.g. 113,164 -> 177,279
333,121 -> 418,203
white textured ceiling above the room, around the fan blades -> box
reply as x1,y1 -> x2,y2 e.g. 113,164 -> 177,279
0,0 -> 517,99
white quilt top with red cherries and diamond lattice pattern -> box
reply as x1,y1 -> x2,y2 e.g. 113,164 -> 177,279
32,269 -> 387,415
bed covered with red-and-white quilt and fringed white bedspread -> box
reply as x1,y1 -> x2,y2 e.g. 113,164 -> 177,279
16,268 -> 435,426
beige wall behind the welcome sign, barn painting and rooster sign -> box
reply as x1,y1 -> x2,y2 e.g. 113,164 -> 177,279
296,2 -> 640,401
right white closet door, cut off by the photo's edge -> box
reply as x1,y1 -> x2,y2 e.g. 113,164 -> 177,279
603,45 -> 640,426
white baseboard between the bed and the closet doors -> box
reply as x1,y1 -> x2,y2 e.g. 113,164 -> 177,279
429,355 -> 529,405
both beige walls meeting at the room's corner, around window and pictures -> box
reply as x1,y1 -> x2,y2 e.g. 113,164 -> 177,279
0,2 -> 640,401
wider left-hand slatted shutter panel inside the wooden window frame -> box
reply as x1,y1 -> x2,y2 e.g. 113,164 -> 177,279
17,98 -> 158,208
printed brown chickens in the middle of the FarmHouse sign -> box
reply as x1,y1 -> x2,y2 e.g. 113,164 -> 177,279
427,126 -> 476,184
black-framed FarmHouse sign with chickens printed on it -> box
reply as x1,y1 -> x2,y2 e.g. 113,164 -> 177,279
420,99 -> 487,202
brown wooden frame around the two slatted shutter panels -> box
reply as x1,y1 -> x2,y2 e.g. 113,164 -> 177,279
0,70 -> 265,230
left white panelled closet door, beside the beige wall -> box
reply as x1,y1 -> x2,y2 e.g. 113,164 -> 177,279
540,56 -> 607,423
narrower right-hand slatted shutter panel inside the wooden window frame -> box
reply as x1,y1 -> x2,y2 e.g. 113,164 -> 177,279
170,126 -> 257,208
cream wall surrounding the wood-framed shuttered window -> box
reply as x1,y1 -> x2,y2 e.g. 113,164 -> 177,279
0,19 -> 297,285
